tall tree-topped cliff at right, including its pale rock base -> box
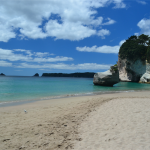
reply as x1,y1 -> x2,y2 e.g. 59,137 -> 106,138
117,34 -> 150,82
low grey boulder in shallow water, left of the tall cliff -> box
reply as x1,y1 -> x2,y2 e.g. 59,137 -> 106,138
93,70 -> 119,86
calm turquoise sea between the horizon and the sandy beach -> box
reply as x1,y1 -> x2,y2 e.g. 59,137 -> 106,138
0,77 -> 150,104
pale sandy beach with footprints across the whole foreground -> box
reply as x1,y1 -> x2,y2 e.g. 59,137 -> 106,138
0,91 -> 150,150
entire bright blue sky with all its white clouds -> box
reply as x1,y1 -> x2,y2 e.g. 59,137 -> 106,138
0,0 -> 150,76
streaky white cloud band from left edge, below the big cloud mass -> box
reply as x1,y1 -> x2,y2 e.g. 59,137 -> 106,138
0,48 -> 73,63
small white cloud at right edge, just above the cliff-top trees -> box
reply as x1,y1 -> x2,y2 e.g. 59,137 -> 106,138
137,18 -> 150,36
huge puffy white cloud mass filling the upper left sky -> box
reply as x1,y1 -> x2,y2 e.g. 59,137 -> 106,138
0,0 -> 126,42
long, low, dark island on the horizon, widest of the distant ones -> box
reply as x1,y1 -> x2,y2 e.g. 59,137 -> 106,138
42,72 -> 95,78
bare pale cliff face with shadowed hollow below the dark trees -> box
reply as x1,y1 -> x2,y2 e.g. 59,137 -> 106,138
118,58 -> 147,82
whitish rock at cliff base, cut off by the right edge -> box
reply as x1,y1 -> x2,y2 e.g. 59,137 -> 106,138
140,63 -> 150,83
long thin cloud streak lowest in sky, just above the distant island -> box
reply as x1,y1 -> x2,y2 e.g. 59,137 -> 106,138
16,63 -> 111,70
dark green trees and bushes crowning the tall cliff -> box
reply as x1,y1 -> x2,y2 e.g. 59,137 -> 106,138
119,34 -> 150,62
